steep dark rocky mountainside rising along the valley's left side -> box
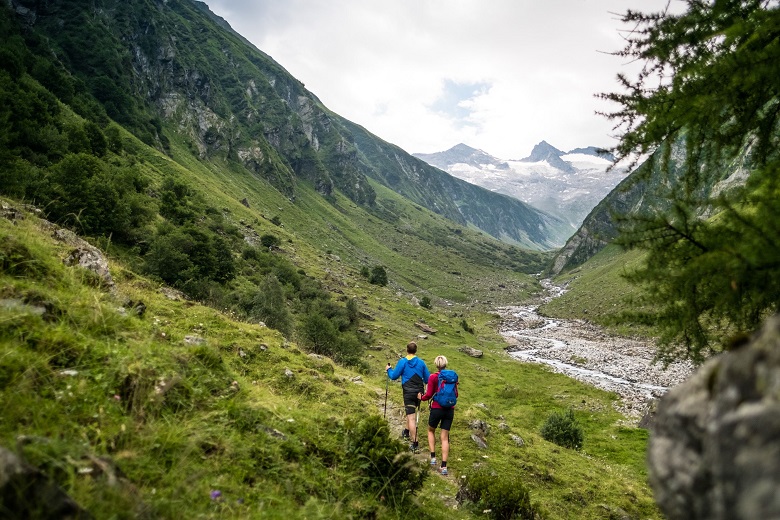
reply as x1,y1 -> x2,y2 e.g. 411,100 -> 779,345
6,0 -> 565,249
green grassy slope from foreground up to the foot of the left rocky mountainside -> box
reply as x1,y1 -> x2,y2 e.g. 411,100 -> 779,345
0,127 -> 658,518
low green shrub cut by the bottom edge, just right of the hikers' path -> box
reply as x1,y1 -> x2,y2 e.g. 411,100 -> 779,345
457,468 -> 536,520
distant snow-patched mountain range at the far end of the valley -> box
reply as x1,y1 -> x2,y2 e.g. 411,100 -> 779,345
413,141 -> 628,233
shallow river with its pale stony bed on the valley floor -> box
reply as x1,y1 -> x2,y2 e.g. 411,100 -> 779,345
497,280 -> 693,417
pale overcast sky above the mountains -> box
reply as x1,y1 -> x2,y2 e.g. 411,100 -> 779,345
206,0 -> 680,159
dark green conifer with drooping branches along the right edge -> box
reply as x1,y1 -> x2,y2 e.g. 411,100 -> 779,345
600,0 -> 780,363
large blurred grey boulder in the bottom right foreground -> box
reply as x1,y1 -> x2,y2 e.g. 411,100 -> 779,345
648,316 -> 780,520
